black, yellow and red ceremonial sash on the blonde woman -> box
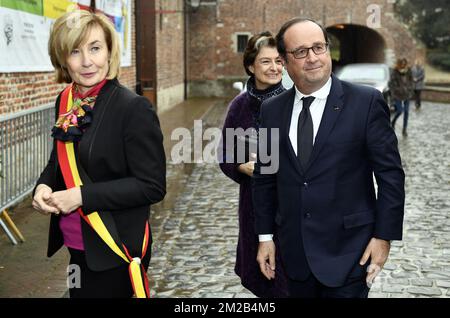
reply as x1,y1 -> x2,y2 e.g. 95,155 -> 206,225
56,85 -> 150,298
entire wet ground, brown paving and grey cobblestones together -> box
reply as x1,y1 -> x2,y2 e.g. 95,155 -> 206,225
0,101 -> 450,298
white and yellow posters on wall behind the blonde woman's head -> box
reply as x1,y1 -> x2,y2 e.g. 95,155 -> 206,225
0,0 -> 132,73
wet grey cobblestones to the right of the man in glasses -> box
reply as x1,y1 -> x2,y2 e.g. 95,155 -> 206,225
370,103 -> 450,298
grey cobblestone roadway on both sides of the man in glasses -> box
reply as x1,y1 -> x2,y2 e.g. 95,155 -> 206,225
149,103 -> 450,298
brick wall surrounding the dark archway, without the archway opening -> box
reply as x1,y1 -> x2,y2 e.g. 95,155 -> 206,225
188,0 -> 415,96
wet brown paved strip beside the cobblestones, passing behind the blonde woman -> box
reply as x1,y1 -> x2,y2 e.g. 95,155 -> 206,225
0,98 -> 224,298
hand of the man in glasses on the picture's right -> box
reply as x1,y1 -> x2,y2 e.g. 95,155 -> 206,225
359,238 -> 391,288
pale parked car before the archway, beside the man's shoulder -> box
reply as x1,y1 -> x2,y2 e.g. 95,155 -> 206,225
336,63 -> 391,105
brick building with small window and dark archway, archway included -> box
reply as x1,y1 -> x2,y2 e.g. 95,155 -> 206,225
188,0 -> 416,96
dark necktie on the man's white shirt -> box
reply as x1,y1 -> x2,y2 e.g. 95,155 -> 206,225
297,96 -> 315,168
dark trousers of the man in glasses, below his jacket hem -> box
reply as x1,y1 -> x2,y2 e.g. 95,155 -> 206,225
288,274 -> 369,298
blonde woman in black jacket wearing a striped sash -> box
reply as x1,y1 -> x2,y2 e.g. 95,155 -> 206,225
33,11 -> 166,298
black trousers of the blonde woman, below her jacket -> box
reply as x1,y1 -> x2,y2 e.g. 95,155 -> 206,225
68,248 -> 150,298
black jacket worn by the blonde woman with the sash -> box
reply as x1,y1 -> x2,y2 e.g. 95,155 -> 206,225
37,80 -> 166,271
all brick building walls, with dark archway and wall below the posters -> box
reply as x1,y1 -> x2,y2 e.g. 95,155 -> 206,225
0,0 -> 416,116
